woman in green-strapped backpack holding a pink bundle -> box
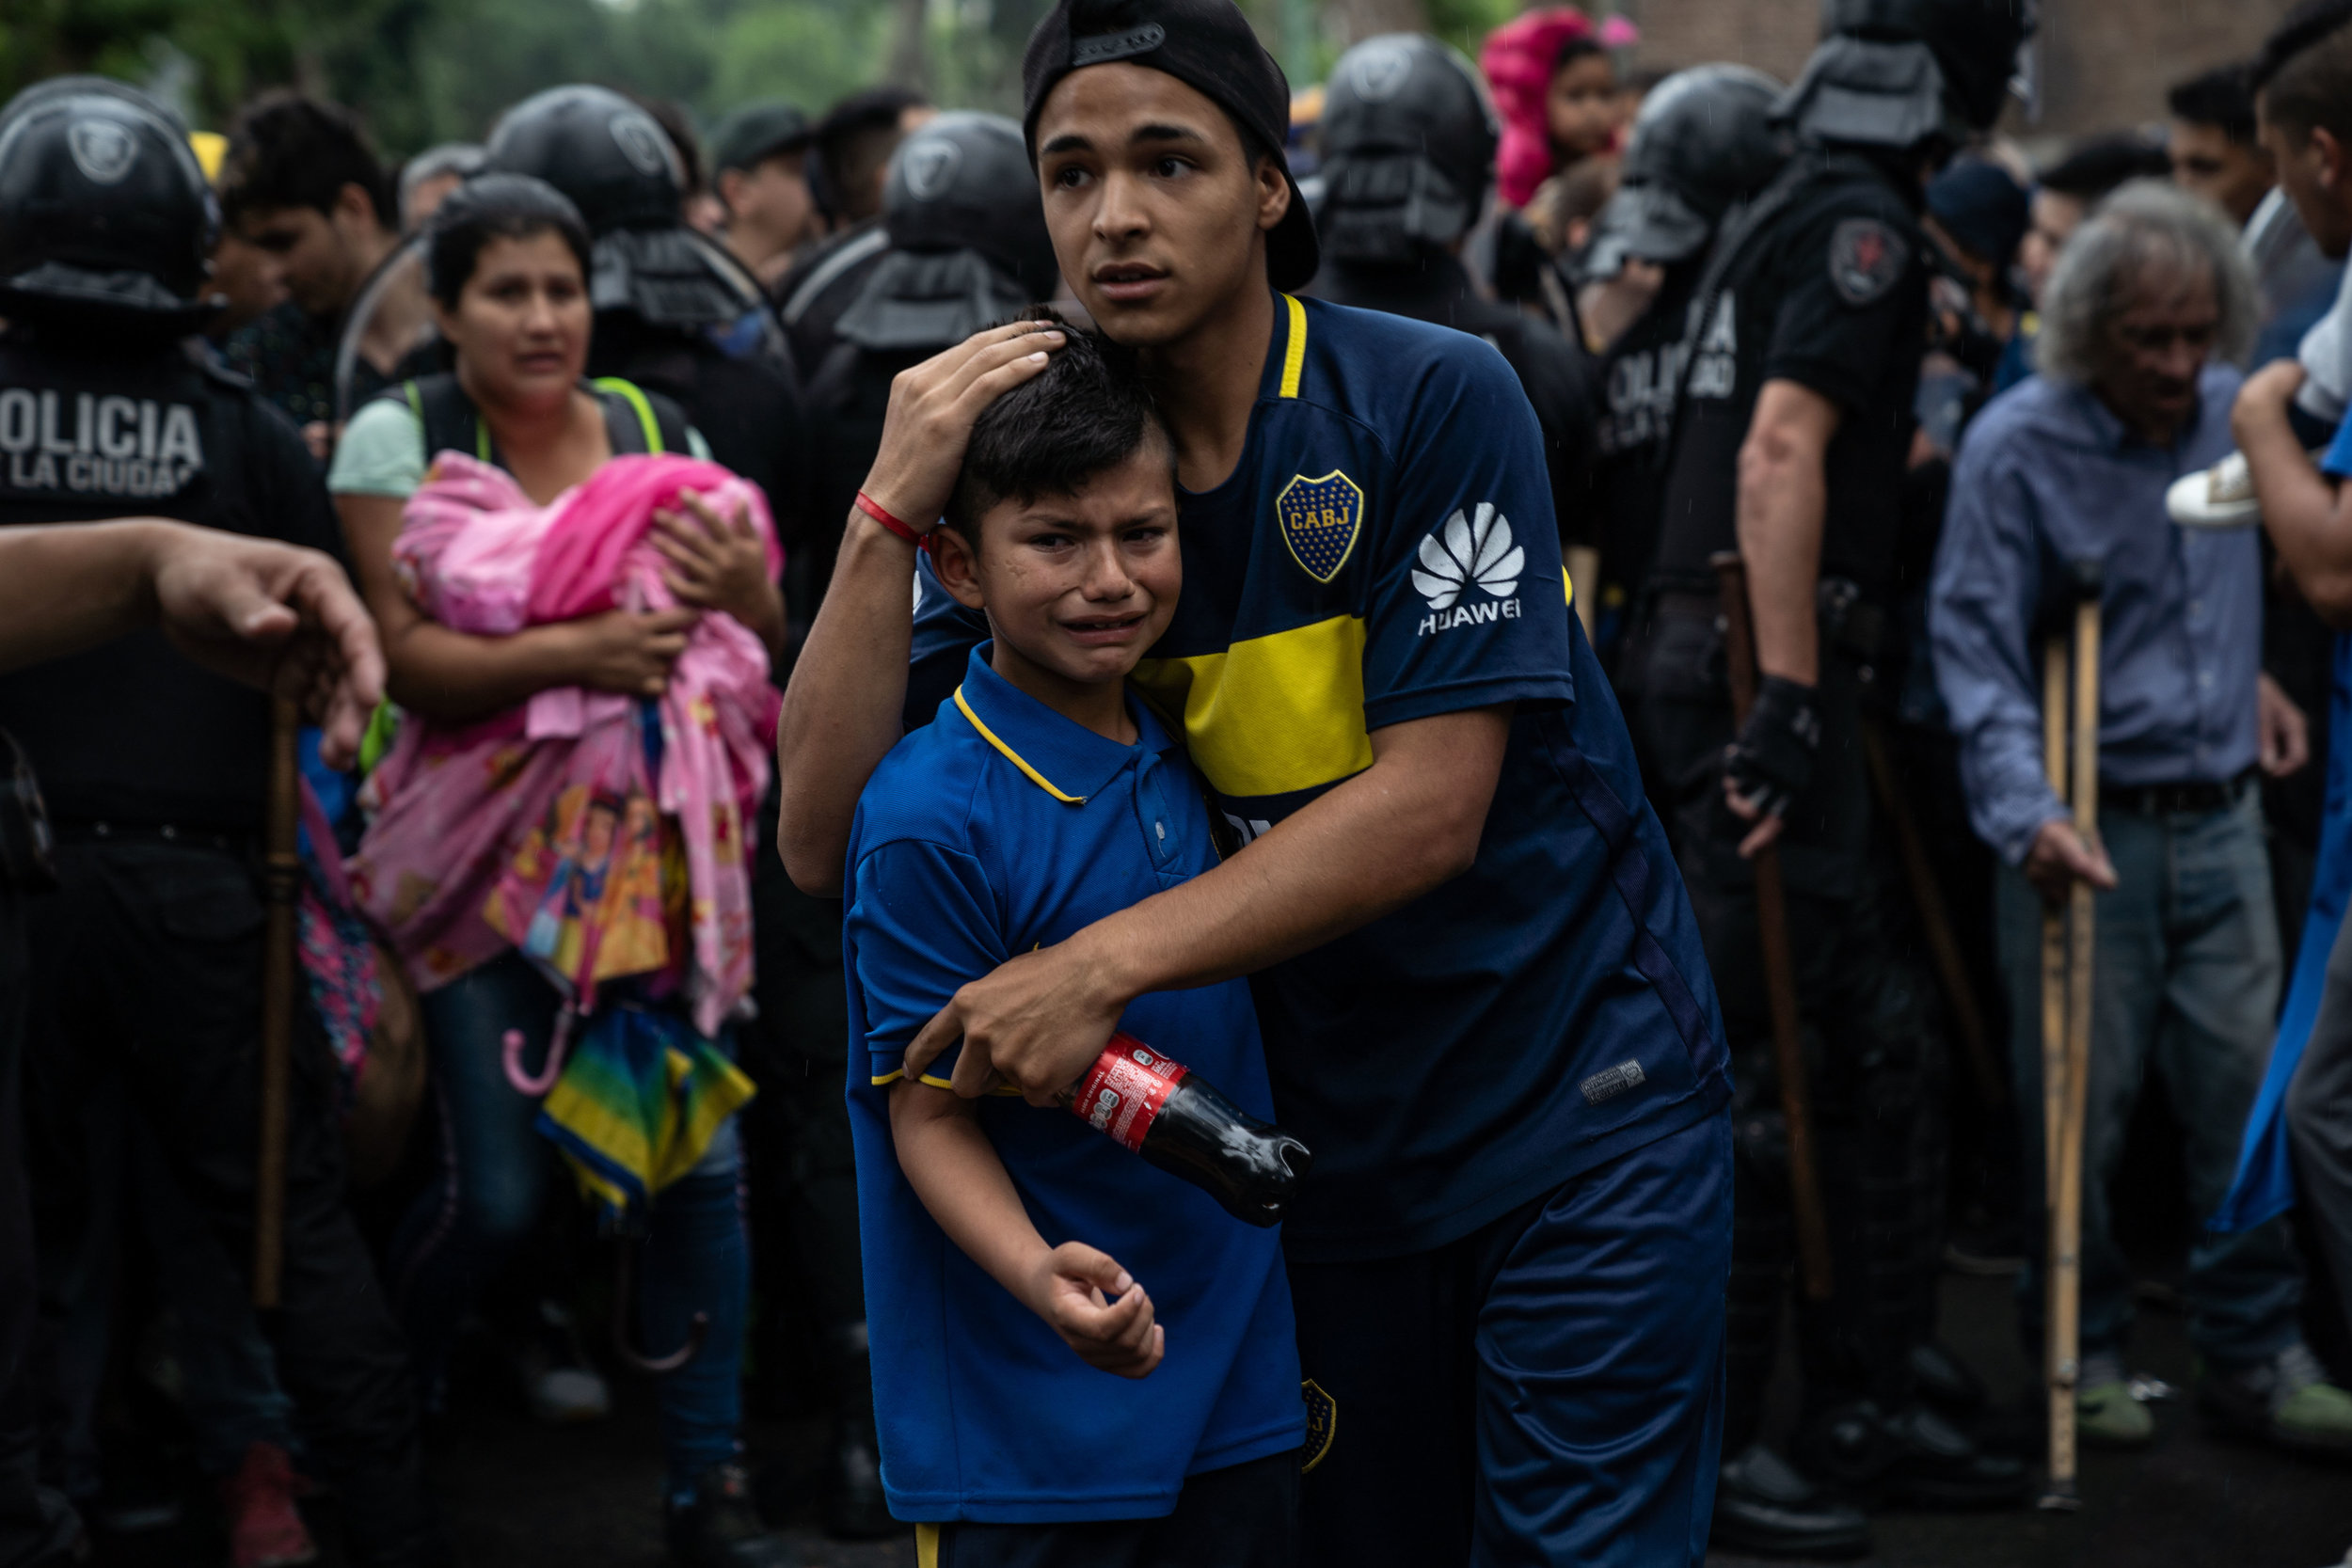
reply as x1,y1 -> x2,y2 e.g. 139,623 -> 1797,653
329,174 -> 788,1568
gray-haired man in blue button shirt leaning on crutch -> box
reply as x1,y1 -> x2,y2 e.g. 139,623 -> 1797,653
1931,183 -> 2352,1449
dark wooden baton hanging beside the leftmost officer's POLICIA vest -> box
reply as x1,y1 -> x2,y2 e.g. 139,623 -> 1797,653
254,696 -> 301,1307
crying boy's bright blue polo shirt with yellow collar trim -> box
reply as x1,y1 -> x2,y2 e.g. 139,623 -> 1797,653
842,646 -> 1306,1524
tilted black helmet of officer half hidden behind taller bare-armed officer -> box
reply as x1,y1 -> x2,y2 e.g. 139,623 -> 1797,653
1579,66 -> 1790,277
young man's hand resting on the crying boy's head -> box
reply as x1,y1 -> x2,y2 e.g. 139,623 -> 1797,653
864,322 -> 1063,529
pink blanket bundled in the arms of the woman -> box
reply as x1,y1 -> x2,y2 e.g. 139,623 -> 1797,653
351,451 -> 784,1035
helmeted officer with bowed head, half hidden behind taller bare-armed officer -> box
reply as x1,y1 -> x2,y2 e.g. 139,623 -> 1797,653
1579,66 -> 1788,690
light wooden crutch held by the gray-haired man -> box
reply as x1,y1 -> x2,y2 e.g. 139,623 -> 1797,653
2042,562 -> 2101,1510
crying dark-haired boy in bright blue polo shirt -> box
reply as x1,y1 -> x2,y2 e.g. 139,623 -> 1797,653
842,336 -> 1306,1568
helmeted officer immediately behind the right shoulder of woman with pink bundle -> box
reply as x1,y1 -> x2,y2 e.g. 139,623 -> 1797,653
487,85 -> 804,552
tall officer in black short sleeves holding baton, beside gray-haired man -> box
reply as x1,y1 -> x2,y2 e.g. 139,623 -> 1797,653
1642,0 -> 2030,1549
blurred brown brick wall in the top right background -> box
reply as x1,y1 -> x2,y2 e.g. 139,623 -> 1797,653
1618,0 -> 2291,138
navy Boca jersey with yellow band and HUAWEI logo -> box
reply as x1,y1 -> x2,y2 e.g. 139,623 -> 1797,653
917,296 -> 1729,1260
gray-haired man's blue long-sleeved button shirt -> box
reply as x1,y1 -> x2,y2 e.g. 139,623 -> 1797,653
1929,364 -> 2263,865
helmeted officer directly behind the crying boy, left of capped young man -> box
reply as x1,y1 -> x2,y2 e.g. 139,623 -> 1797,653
748,113 -> 1058,1535
